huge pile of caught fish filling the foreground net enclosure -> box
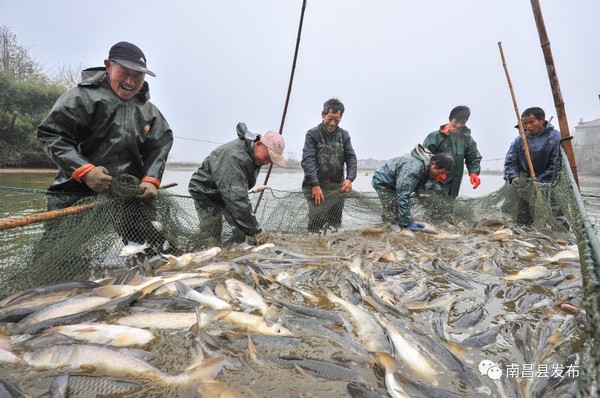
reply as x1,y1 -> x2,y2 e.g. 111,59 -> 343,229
0,220 -> 586,397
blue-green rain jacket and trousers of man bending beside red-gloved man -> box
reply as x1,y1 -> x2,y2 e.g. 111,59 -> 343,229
371,145 -> 433,226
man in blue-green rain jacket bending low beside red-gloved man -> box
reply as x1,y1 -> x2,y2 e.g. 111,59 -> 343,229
371,145 -> 454,229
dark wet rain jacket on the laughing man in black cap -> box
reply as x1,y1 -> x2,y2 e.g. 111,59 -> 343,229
37,67 -> 173,195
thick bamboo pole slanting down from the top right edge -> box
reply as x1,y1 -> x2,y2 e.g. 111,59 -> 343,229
531,0 -> 579,188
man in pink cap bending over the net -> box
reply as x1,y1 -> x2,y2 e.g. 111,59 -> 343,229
188,123 -> 285,245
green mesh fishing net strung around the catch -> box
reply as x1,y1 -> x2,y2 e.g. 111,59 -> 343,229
0,148 -> 600,397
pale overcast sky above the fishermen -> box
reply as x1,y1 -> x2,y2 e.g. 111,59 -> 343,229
0,0 -> 600,168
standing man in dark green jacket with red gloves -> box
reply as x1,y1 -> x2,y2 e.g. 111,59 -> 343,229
423,105 -> 481,198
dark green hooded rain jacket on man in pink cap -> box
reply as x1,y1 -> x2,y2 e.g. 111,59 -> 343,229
188,125 -> 261,236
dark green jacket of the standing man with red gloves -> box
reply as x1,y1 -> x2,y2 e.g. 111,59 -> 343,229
423,126 -> 481,198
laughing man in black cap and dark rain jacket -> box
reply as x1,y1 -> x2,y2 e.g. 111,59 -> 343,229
37,41 -> 173,246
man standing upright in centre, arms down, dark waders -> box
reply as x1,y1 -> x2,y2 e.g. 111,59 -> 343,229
301,98 -> 357,232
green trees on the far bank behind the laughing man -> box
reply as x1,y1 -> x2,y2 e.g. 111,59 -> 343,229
0,26 -> 74,168
